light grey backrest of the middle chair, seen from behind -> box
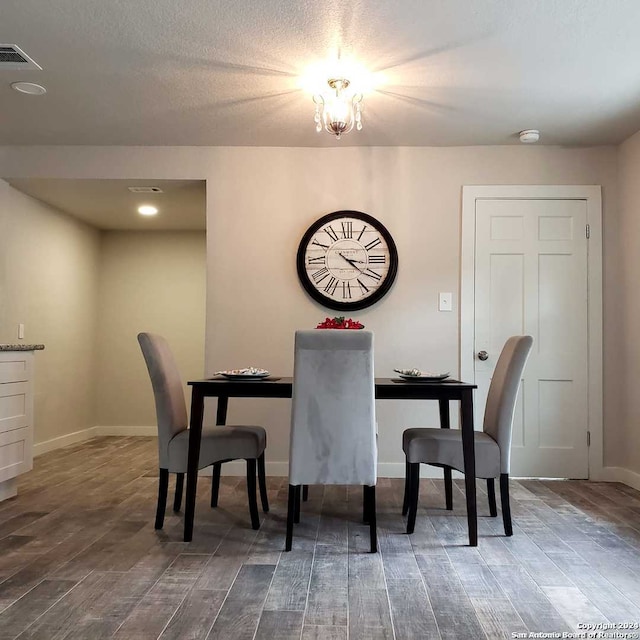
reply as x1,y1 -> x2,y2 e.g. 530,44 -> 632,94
289,329 -> 377,486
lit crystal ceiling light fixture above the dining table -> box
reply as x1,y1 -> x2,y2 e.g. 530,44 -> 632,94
313,78 -> 362,140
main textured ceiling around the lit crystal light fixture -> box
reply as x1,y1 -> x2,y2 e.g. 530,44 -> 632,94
0,0 -> 640,146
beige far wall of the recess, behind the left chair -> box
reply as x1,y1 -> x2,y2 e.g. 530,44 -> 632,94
95,231 -> 206,426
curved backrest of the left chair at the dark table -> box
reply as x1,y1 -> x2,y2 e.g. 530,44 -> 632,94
138,333 -> 187,469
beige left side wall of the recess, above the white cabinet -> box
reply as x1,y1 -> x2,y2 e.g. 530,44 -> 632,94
0,180 -> 100,444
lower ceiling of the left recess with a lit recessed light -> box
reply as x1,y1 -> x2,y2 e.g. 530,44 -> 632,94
7,178 -> 206,231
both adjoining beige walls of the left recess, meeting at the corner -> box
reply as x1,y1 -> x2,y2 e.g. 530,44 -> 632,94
0,180 -> 206,442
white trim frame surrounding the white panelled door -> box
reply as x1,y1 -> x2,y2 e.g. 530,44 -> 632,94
460,185 -> 604,480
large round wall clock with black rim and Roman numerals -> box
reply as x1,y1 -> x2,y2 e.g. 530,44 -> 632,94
297,211 -> 398,311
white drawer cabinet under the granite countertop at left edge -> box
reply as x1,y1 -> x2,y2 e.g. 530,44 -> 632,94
0,351 -> 34,500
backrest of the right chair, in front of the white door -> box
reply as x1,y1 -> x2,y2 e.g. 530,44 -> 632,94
483,336 -> 533,473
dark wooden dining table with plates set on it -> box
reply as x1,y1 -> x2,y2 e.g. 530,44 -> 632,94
184,376 -> 478,547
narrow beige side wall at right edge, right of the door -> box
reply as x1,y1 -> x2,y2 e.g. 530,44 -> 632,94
611,132 -> 640,474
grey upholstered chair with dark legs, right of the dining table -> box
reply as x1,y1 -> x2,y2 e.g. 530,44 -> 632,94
402,336 -> 533,536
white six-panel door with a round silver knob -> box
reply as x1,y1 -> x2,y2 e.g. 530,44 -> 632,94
474,199 -> 589,478
